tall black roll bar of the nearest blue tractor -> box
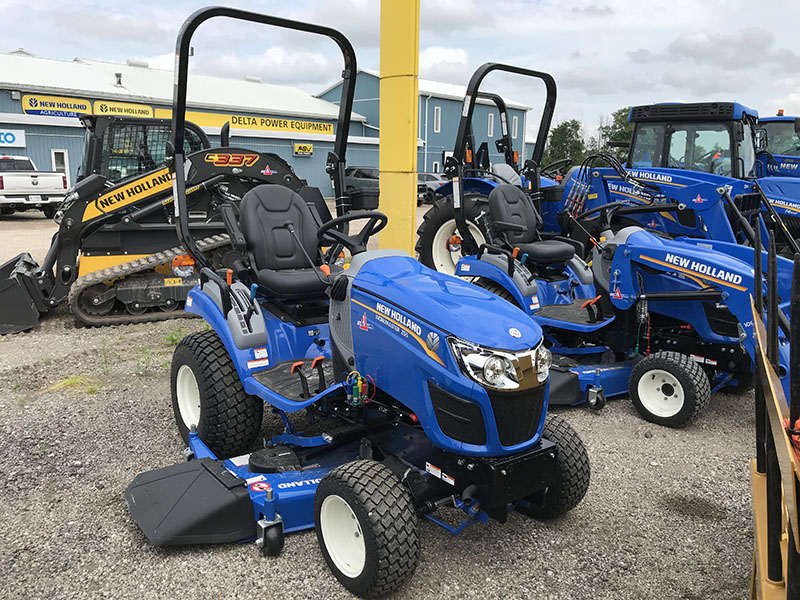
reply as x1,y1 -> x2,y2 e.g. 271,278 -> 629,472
168,6 -> 356,268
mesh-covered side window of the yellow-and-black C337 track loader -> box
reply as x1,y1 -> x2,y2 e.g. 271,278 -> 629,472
99,123 -> 203,183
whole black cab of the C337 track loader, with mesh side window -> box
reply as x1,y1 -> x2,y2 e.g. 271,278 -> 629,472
78,115 -> 211,183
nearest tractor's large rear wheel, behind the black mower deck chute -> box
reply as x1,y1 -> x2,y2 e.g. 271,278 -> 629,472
171,331 -> 264,458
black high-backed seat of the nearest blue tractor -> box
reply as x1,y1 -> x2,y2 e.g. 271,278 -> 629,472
232,184 -> 342,300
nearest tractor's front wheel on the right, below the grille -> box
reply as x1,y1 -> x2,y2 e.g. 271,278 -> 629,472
517,414 -> 591,520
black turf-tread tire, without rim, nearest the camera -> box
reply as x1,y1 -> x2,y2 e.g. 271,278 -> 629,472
314,460 -> 420,598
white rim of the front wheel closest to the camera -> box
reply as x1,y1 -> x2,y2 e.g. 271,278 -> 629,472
319,495 -> 367,579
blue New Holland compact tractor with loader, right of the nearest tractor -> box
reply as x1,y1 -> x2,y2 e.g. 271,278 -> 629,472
446,63 -> 791,427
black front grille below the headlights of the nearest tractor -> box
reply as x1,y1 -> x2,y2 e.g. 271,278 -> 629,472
486,385 -> 545,446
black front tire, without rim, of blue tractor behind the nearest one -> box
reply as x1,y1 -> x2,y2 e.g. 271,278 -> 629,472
628,351 -> 711,427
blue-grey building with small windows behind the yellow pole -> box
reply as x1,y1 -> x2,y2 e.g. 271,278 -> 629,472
317,69 -> 530,173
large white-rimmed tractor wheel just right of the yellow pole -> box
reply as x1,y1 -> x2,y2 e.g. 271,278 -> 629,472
415,194 -> 486,275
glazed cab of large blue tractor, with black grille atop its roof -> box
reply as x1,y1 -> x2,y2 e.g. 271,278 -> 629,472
627,102 -> 758,179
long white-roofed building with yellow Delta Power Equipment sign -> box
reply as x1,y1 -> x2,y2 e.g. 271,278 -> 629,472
0,49 -> 378,195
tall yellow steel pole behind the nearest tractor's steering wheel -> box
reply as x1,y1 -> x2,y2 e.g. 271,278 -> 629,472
379,0 -> 420,255
